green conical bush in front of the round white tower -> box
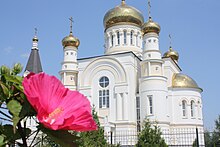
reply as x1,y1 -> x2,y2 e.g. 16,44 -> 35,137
136,119 -> 167,147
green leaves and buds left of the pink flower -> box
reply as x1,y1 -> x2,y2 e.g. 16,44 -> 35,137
0,63 -> 31,146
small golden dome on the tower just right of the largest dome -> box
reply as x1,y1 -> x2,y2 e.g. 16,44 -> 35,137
142,17 -> 160,34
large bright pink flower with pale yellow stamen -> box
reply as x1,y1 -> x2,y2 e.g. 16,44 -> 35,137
23,73 -> 97,131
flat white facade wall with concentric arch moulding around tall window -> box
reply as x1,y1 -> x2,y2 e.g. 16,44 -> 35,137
79,53 -> 140,134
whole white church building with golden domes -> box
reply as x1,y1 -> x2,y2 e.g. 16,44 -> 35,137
25,0 -> 204,145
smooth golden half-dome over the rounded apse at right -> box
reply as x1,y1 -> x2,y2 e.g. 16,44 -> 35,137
172,73 -> 202,90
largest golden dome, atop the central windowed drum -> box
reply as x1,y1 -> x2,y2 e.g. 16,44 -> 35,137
103,0 -> 144,29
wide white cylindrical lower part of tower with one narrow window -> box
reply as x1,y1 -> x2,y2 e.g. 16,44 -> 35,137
140,76 -> 169,126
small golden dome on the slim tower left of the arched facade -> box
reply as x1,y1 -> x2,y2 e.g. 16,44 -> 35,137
62,32 -> 80,48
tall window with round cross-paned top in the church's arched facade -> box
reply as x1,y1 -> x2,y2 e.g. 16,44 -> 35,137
99,76 -> 109,108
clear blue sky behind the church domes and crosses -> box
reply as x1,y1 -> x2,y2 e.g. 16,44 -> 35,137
0,0 -> 220,129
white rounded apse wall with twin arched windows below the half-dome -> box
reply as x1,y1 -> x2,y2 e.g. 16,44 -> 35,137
169,88 -> 203,126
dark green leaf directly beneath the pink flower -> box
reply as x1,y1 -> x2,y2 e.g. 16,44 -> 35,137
39,125 -> 78,147
